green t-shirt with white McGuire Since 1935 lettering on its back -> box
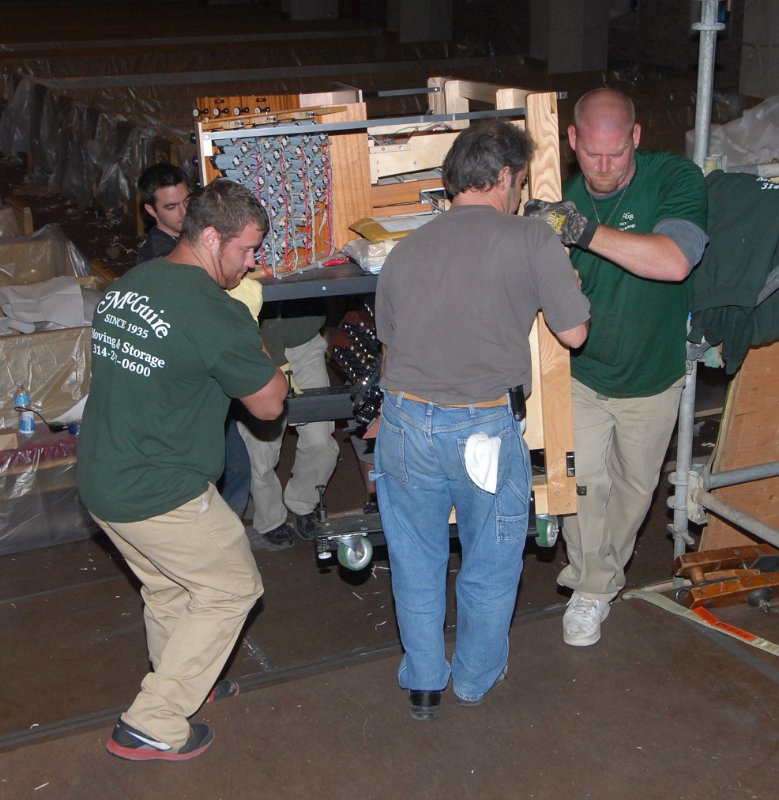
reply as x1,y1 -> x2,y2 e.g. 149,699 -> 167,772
78,258 -> 274,522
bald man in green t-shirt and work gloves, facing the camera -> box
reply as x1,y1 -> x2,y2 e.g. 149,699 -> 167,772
525,89 -> 708,646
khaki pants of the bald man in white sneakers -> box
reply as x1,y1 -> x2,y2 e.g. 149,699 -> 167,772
557,378 -> 684,600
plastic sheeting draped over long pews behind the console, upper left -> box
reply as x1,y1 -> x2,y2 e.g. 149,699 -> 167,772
0,36 -> 508,216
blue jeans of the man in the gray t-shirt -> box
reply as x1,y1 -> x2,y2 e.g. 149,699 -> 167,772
372,393 -> 530,700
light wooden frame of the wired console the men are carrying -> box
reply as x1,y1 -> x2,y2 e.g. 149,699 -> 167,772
197,77 -> 576,515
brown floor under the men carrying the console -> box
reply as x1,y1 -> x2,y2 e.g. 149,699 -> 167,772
0,418 -> 779,800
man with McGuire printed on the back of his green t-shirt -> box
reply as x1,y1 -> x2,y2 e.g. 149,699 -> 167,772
78,180 -> 287,761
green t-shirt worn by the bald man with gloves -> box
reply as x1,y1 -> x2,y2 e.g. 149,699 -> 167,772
563,151 -> 706,397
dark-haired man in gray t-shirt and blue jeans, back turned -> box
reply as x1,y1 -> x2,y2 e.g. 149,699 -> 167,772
373,120 -> 589,720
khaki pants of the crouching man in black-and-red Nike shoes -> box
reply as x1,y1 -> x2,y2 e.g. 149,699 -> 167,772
95,485 -> 262,747
